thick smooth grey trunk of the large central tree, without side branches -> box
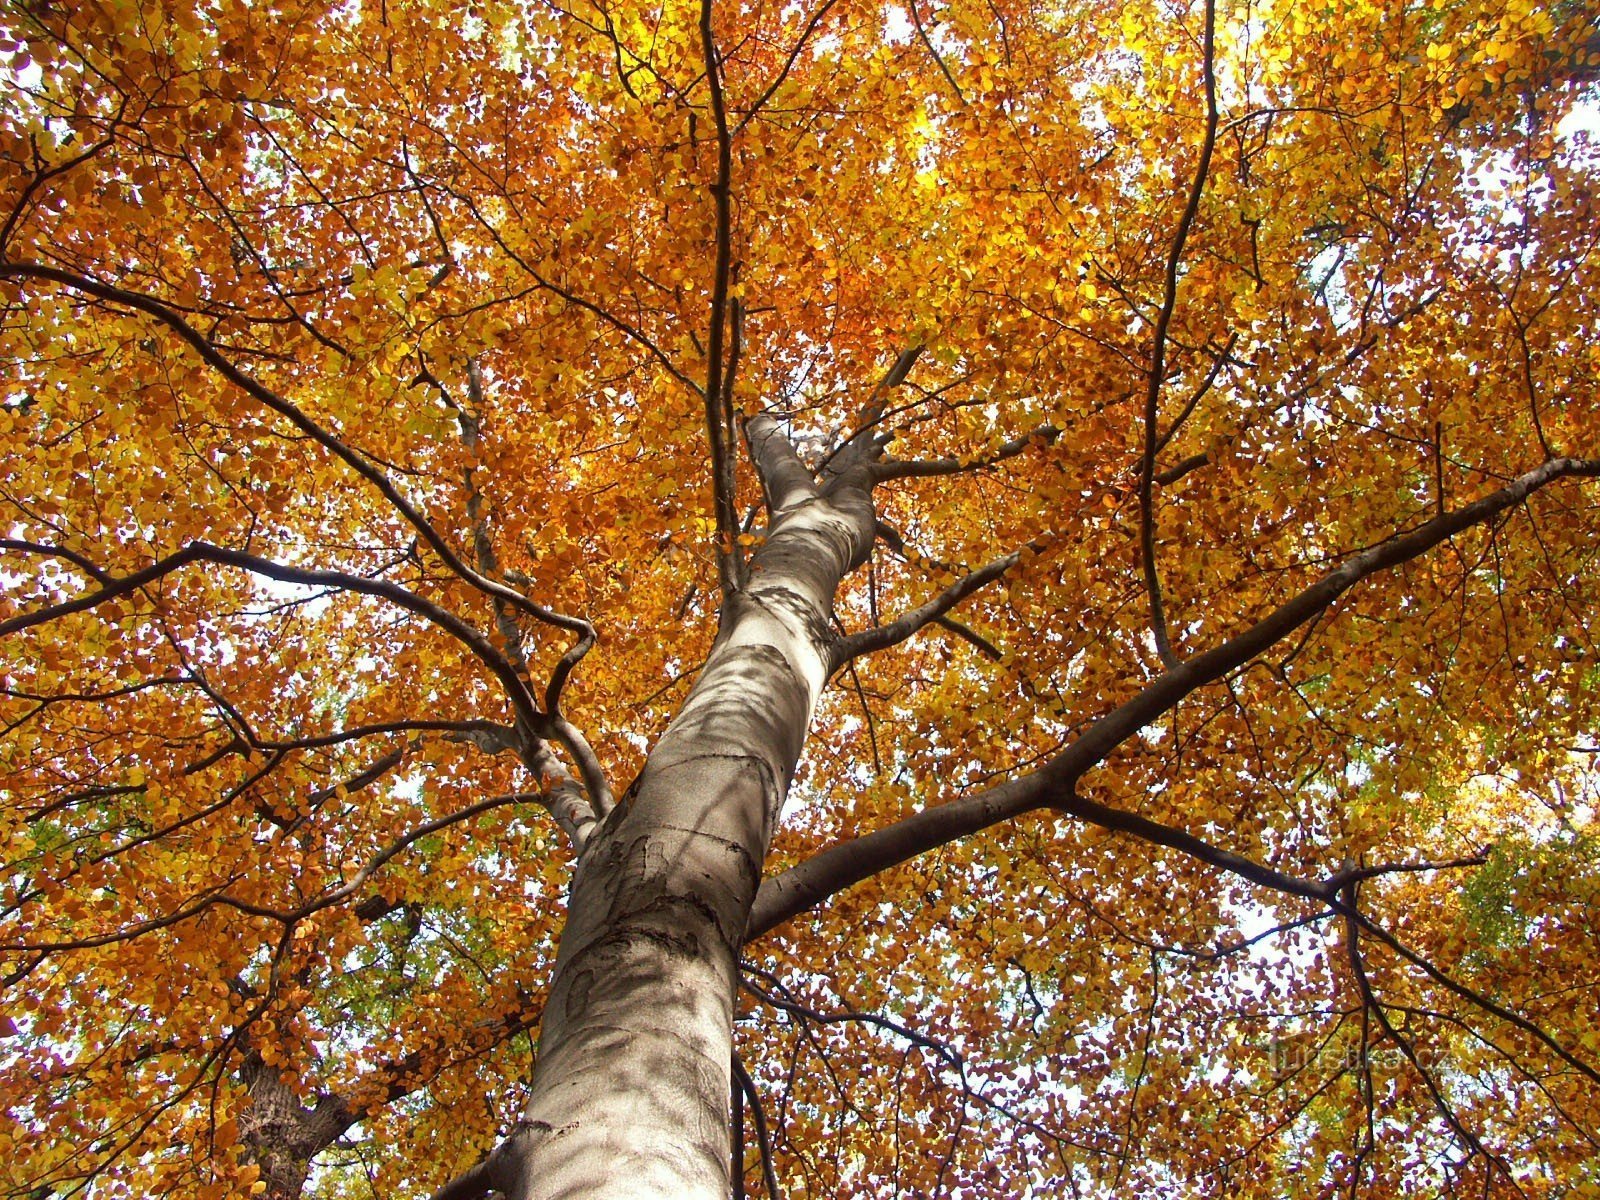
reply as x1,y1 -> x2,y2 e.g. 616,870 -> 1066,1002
501,419 -> 875,1200
